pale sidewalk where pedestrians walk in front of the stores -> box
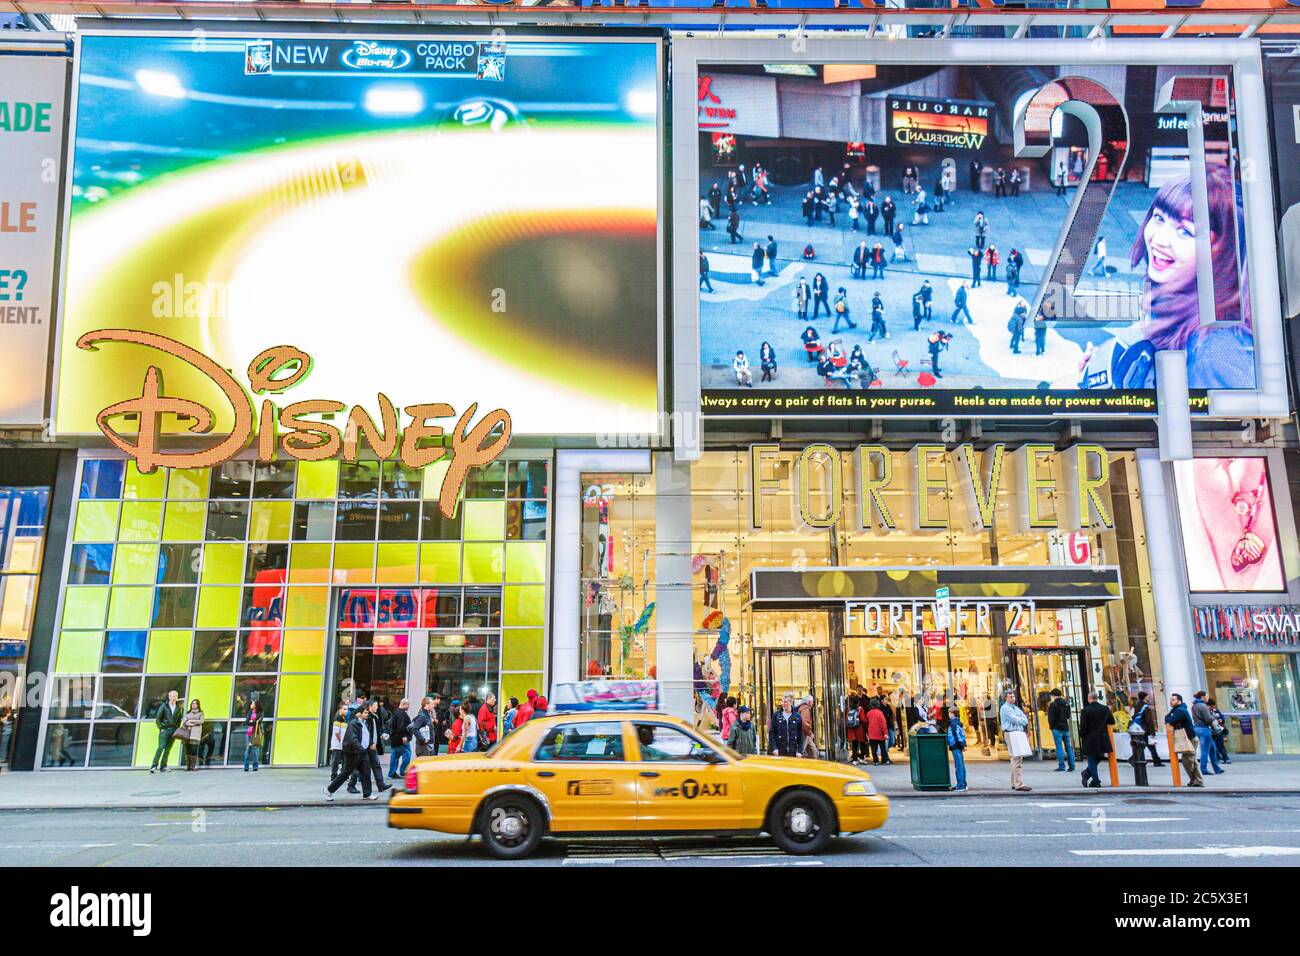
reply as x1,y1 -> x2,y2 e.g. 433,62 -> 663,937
0,754 -> 1300,810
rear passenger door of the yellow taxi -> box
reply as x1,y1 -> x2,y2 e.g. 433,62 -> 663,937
525,721 -> 637,832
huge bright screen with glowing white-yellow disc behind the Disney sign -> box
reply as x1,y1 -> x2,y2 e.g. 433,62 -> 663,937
56,34 -> 660,434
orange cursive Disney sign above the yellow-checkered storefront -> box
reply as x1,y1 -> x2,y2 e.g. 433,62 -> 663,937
77,329 -> 511,518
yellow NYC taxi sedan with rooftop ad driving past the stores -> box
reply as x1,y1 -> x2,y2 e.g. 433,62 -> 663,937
389,711 -> 889,860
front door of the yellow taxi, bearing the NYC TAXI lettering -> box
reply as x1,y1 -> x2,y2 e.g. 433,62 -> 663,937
628,719 -> 745,830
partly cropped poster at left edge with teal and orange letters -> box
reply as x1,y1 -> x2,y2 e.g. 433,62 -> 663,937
0,55 -> 68,425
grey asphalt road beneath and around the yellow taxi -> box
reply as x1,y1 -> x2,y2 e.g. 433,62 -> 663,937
0,793 -> 1300,868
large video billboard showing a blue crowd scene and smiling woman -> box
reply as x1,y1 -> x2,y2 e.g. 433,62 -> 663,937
697,62 -> 1256,416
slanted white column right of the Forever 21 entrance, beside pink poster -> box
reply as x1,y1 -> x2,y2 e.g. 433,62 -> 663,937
1138,449 -> 1200,700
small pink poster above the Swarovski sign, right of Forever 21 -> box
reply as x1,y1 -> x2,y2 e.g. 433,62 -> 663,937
1174,458 -> 1286,592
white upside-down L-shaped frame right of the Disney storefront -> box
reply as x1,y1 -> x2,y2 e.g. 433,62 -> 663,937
550,449 -> 650,683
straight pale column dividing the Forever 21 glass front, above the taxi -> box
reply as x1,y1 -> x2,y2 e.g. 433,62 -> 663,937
654,451 -> 696,721
